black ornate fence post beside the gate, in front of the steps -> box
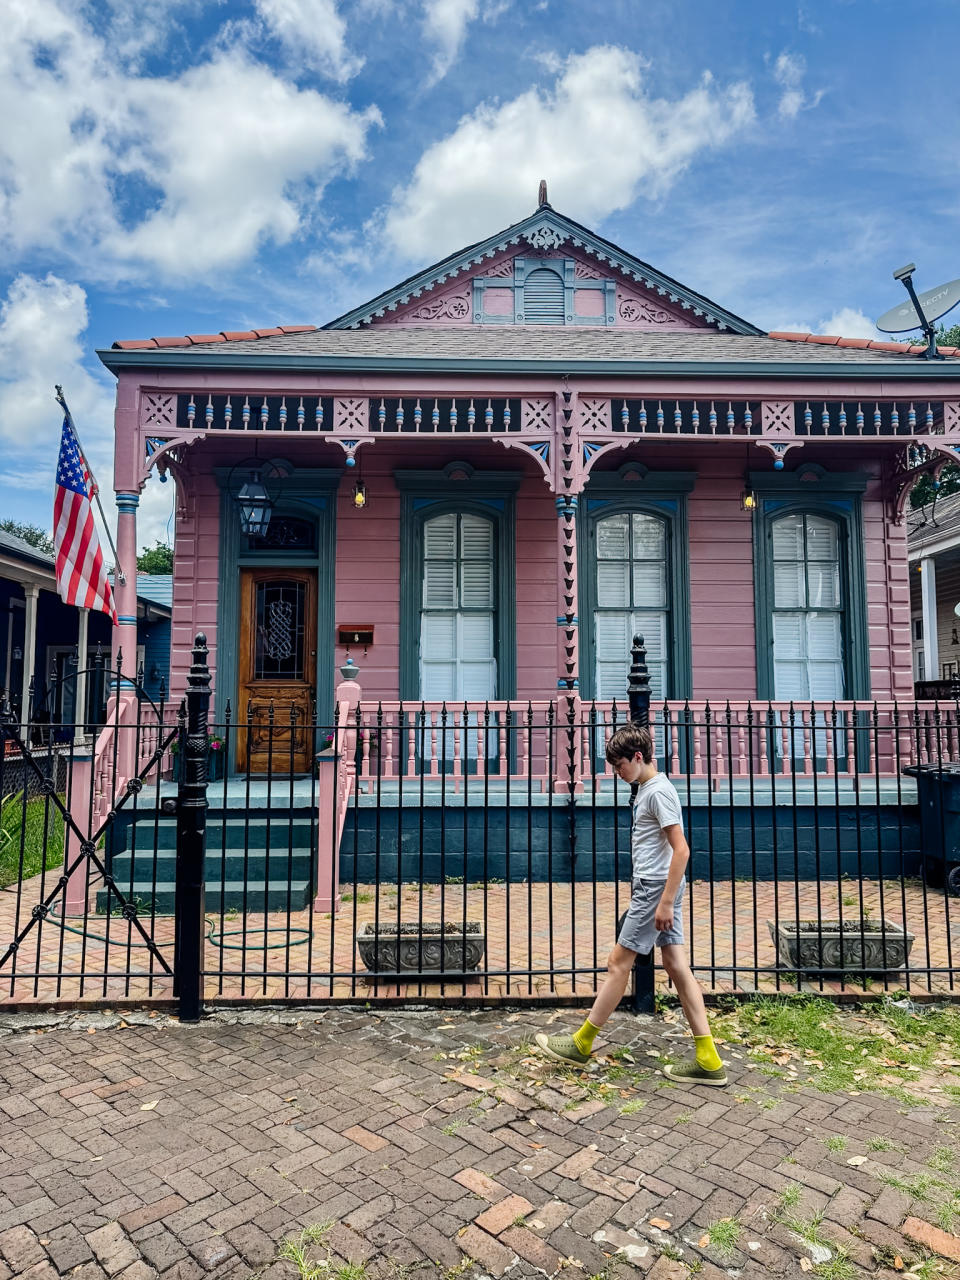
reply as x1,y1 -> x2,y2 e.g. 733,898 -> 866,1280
174,632 -> 210,1023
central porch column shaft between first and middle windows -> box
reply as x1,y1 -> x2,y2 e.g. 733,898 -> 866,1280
556,494 -> 584,791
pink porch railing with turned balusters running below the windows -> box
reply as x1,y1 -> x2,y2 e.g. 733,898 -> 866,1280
358,699 -> 960,791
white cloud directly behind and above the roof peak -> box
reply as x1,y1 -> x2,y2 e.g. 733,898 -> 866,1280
383,45 -> 754,257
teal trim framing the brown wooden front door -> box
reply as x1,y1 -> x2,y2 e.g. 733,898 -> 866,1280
214,467 -> 343,742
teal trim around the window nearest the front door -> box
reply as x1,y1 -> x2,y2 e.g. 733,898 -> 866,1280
394,462 -> 524,700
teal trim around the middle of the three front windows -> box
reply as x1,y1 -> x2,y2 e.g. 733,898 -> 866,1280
577,462 -> 696,701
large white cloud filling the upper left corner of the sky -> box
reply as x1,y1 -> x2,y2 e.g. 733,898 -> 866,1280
0,0 -> 380,279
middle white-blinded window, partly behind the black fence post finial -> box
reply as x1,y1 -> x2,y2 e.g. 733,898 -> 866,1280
593,512 -> 669,700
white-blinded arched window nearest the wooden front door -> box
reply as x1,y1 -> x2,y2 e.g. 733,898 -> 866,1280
420,512 -> 497,701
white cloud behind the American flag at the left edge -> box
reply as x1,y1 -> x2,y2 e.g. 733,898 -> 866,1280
0,274 -> 174,554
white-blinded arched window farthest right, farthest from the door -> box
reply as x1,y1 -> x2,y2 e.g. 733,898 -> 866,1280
771,512 -> 845,701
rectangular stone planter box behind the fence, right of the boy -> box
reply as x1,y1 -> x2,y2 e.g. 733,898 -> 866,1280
767,916 -> 914,975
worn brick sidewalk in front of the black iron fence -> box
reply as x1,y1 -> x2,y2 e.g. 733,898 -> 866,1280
0,1009 -> 960,1280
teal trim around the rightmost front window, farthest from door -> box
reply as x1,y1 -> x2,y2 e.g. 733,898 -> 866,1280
748,463 -> 870,699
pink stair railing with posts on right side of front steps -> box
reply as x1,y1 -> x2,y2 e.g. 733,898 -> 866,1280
314,677 -> 361,911
